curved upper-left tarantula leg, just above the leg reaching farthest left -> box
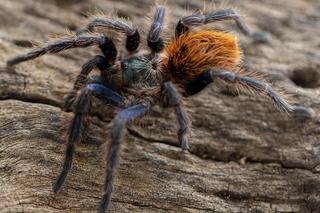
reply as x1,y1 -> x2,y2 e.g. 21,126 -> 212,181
78,17 -> 140,52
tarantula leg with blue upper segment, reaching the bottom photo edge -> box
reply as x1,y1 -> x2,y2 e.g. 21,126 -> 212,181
99,104 -> 150,213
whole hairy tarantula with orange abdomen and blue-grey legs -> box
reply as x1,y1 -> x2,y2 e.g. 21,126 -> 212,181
7,5 -> 293,212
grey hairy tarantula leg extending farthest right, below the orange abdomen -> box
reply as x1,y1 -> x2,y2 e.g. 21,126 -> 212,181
208,69 -> 294,112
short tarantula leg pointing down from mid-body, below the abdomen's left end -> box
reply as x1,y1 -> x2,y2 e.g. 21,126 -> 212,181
162,82 -> 189,150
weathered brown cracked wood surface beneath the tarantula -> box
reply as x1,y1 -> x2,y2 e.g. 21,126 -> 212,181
0,0 -> 320,213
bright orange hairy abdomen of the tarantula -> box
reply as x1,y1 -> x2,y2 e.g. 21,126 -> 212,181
163,31 -> 241,85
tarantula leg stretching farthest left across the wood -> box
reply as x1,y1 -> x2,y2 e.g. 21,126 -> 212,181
7,35 -> 116,66
